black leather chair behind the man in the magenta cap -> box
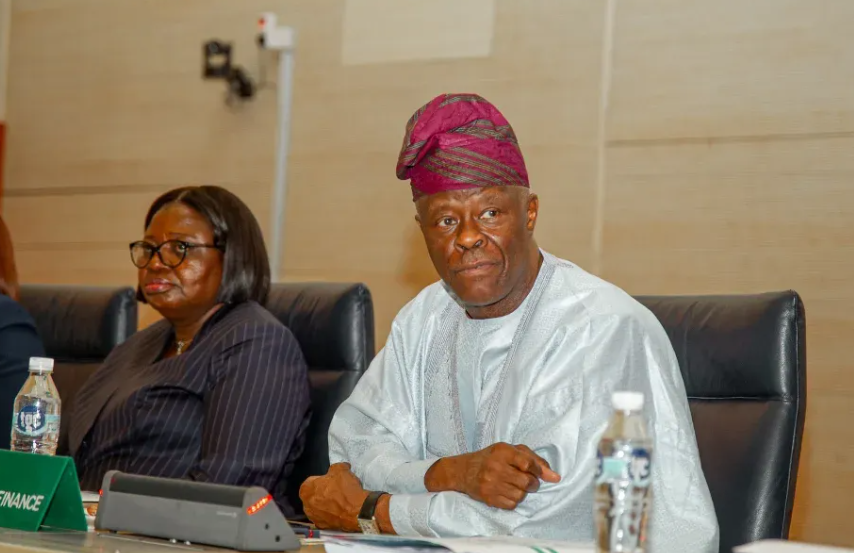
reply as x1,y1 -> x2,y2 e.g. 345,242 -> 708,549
637,292 -> 806,552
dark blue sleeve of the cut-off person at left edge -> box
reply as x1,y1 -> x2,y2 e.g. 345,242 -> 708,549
0,320 -> 44,449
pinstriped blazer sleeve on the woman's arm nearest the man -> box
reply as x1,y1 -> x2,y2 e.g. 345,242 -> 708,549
189,323 -> 310,492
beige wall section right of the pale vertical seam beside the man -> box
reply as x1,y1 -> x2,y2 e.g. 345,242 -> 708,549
600,0 -> 854,545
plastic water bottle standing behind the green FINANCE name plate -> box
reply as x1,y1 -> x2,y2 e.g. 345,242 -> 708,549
12,357 -> 60,455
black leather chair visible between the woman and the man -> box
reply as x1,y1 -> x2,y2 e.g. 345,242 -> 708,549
266,283 -> 374,512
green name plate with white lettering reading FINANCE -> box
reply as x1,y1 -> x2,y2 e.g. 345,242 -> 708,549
0,450 -> 86,532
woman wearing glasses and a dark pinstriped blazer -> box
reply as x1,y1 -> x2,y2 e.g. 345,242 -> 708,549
68,186 -> 309,516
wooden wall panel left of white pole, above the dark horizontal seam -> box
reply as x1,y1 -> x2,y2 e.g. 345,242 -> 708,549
7,0 -> 283,189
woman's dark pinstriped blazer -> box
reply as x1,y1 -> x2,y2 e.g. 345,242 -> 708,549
64,302 -> 309,516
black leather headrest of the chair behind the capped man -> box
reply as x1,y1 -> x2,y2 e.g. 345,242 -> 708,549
636,291 -> 806,400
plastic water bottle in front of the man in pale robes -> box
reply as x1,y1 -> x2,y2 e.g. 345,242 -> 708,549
594,392 -> 652,553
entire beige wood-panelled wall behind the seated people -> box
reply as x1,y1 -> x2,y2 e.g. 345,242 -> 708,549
0,0 -> 854,545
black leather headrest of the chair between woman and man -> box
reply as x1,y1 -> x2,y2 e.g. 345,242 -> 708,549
266,282 -> 374,372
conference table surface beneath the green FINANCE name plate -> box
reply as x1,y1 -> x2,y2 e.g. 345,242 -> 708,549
0,529 -> 324,553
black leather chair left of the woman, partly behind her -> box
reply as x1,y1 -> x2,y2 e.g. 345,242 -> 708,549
20,285 -> 137,454
